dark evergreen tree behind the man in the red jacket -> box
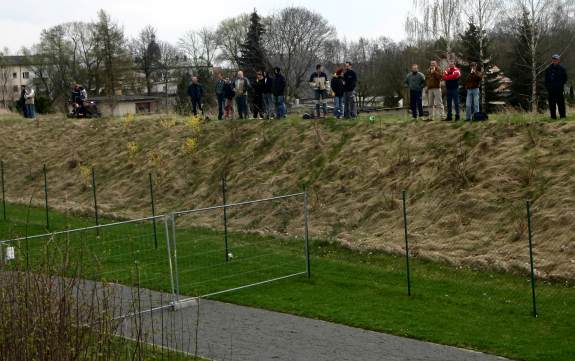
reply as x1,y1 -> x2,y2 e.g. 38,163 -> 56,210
459,23 -> 506,112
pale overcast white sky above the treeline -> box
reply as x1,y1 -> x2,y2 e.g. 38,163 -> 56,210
0,0 -> 412,53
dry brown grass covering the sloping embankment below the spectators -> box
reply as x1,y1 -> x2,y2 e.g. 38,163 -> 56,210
0,115 -> 575,278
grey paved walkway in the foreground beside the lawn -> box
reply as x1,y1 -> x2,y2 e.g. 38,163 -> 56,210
110,289 -> 510,361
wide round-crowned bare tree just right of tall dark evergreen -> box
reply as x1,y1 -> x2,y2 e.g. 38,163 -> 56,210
264,7 -> 336,96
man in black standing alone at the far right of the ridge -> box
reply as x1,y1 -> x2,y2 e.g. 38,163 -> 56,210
545,54 -> 567,119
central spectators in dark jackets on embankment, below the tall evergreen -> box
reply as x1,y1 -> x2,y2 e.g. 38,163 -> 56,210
188,62 -> 357,120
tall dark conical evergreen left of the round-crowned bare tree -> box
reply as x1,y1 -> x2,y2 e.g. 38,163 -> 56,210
238,10 -> 268,81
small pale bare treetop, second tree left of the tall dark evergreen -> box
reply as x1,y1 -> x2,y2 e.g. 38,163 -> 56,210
179,28 -> 218,67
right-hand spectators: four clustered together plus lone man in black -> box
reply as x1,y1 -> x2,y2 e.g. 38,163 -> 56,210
405,54 -> 567,121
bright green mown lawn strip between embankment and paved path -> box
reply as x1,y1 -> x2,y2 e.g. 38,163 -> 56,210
0,205 -> 575,361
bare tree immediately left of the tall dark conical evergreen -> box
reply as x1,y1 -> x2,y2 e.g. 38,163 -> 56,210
216,14 -> 250,67
